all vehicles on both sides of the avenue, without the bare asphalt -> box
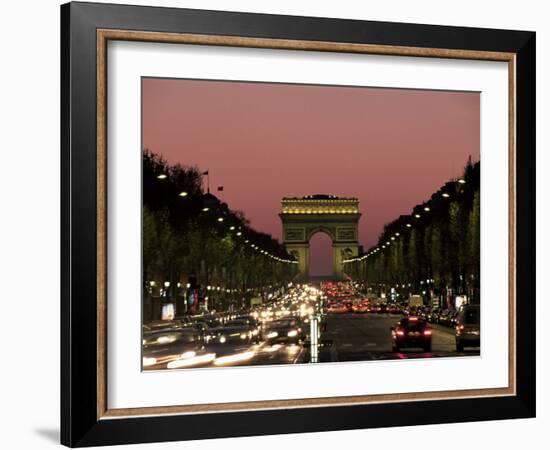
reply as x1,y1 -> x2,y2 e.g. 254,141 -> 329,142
142,282 -> 480,369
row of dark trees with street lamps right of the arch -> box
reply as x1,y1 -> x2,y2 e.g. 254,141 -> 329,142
345,161 -> 480,306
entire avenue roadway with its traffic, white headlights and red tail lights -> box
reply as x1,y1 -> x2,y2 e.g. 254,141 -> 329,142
142,282 -> 480,370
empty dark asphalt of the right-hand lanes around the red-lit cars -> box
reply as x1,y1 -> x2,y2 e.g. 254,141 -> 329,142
320,314 -> 479,361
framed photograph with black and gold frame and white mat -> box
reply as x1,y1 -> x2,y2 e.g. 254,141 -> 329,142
61,3 -> 536,447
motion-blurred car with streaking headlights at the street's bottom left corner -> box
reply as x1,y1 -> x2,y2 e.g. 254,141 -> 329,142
143,328 -> 208,368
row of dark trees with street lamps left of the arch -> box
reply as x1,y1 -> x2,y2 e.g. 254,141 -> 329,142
142,150 -> 297,322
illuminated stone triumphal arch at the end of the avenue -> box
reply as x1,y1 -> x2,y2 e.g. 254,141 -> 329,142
279,194 -> 361,279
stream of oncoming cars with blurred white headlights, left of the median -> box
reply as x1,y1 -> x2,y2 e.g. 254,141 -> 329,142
143,285 -> 321,369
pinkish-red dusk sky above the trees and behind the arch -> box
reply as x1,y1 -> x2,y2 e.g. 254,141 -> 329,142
143,78 -> 480,274
